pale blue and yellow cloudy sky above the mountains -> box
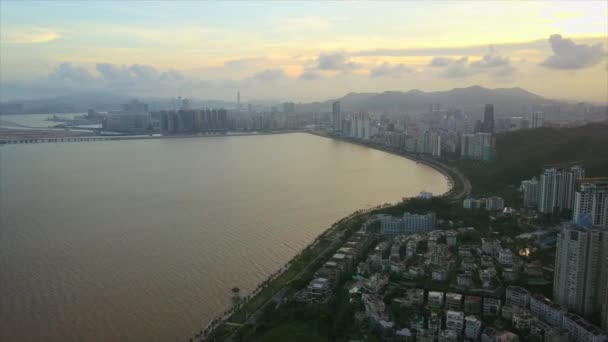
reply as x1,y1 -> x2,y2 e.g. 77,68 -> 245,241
0,0 -> 608,102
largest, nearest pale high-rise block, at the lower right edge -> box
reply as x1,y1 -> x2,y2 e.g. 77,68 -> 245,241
553,225 -> 608,316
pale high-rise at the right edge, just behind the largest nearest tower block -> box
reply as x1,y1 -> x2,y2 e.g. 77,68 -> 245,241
572,178 -> 608,227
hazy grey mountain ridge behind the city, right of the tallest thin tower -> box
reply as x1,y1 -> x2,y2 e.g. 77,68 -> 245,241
299,86 -> 555,113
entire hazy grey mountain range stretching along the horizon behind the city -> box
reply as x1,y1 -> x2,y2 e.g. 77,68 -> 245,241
0,86 -> 555,114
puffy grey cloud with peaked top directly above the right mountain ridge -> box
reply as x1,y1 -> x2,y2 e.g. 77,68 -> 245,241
429,46 -> 517,79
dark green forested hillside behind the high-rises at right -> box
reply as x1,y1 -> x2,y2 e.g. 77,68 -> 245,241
459,123 -> 608,197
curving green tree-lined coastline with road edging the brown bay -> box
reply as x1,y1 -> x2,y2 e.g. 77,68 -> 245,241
197,130 -> 470,341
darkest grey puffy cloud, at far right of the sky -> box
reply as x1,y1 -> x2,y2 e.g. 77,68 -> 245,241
541,34 -> 606,69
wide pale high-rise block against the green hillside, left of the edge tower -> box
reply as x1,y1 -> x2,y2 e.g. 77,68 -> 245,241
538,166 -> 585,214
